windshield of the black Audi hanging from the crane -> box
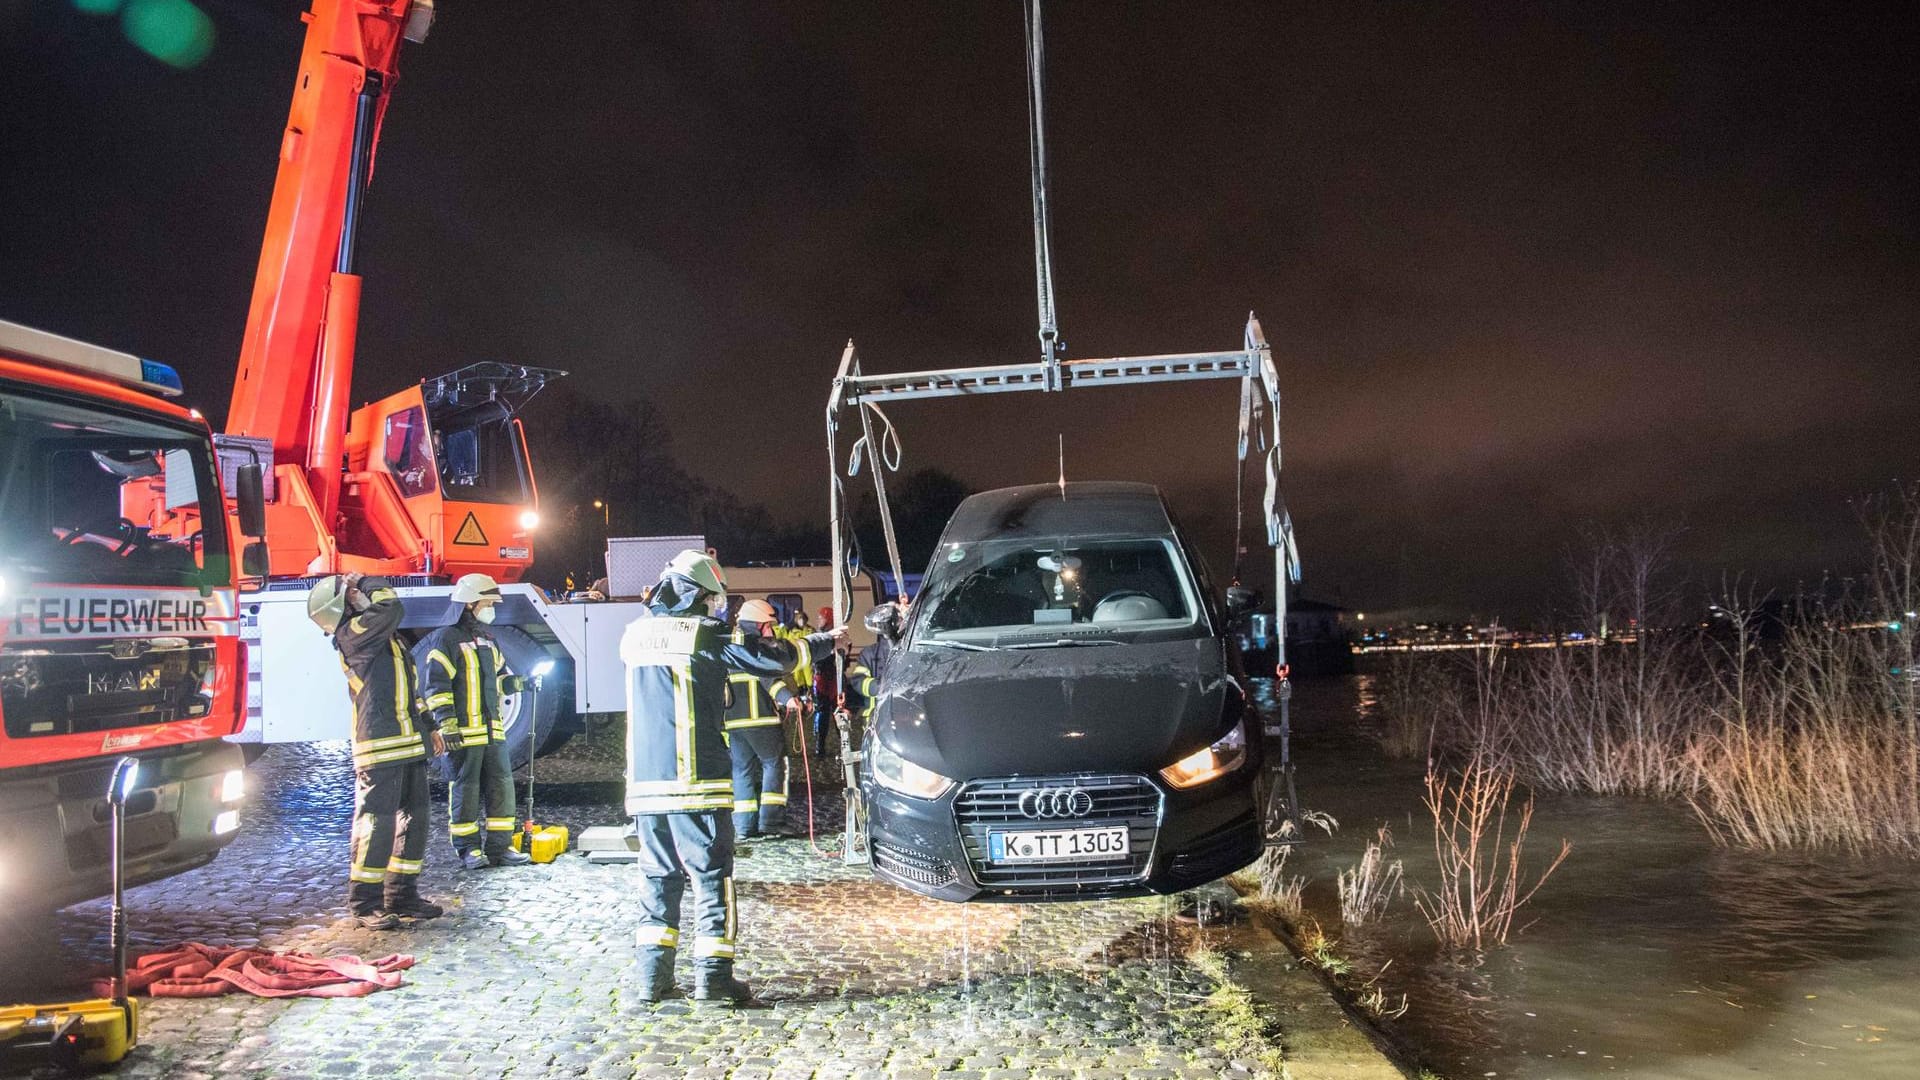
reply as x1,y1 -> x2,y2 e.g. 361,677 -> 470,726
914,538 -> 1200,648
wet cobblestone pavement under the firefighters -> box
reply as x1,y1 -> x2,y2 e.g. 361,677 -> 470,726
0,718 -> 1290,1078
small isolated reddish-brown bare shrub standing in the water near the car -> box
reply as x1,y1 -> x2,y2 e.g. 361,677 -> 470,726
1413,753 -> 1572,951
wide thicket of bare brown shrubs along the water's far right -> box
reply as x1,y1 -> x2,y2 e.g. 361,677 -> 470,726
1377,484 -> 1920,851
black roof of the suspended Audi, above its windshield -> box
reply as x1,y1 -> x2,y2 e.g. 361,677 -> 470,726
941,480 -> 1173,544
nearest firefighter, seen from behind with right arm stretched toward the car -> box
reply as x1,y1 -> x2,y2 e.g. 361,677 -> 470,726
620,550 -> 833,1003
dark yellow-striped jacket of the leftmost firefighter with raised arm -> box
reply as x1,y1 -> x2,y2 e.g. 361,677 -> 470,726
334,588 -> 426,769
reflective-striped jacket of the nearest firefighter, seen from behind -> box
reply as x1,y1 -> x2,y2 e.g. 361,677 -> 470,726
620,575 -> 817,815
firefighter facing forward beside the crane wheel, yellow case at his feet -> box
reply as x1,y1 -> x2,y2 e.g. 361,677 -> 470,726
420,575 -> 532,871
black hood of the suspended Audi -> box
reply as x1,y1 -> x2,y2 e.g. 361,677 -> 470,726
874,638 -> 1244,780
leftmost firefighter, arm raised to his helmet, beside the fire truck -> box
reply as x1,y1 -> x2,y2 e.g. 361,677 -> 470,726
307,575 -> 442,930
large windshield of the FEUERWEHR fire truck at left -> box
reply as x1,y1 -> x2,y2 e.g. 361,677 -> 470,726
0,384 -> 230,588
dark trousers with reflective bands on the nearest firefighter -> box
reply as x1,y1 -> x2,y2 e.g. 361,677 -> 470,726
634,811 -> 739,969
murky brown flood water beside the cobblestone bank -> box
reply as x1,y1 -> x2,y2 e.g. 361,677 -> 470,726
1263,675 -> 1920,1080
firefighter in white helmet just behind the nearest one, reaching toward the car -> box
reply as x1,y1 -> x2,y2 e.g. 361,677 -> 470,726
726,600 -> 833,838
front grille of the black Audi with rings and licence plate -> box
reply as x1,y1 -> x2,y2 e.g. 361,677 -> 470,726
954,774 -> 1162,892
